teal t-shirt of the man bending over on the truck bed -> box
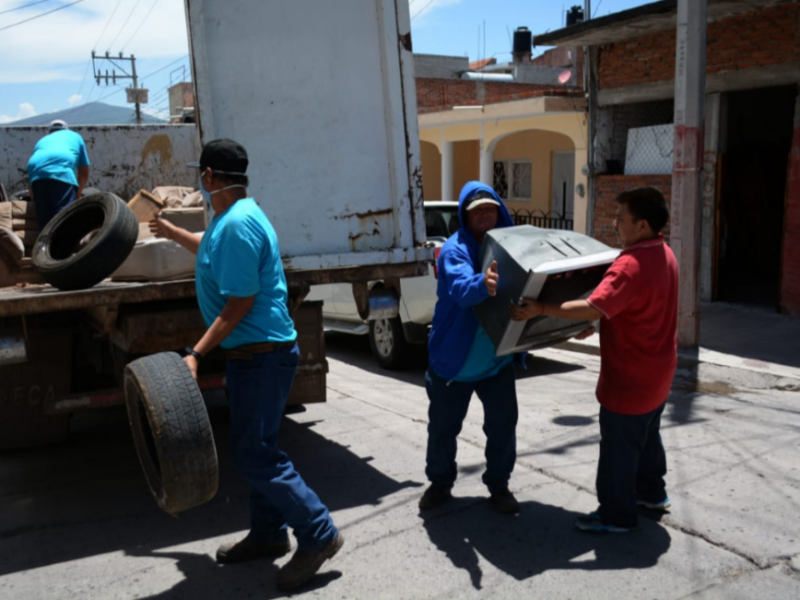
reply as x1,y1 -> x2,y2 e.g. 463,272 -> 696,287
28,129 -> 89,186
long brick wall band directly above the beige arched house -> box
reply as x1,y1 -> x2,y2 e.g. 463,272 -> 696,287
416,77 -> 583,114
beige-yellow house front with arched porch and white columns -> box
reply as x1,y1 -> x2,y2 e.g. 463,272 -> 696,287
419,97 -> 587,233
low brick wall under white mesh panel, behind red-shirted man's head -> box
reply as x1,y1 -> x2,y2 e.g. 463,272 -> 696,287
592,175 -> 672,248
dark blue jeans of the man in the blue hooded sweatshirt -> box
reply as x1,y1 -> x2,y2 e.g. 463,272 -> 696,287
425,364 -> 517,493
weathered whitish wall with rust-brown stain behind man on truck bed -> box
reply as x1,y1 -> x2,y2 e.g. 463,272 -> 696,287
0,125 -> 200,201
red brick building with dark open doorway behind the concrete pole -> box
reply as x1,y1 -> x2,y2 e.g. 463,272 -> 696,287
534,0 -> 800,316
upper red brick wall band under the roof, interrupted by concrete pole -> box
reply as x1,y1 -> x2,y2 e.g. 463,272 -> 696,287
599,2 -> 800,89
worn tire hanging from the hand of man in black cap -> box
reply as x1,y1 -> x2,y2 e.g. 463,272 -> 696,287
124,352 -> 219,516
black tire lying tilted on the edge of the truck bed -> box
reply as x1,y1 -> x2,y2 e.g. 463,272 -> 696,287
33,192 -> 139,290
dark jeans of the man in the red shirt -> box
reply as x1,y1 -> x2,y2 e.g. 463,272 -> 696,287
597,404 -> 667,527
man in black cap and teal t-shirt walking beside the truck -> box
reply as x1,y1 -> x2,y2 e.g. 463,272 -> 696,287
150,140 -> 344,589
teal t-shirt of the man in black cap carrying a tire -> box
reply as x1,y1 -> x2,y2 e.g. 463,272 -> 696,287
195,198 -> 297,349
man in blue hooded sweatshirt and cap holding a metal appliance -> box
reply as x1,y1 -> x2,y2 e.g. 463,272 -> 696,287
419,181 -> 519,513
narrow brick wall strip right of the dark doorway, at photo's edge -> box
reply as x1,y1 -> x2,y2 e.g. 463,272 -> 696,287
780,124 -> 800,317
